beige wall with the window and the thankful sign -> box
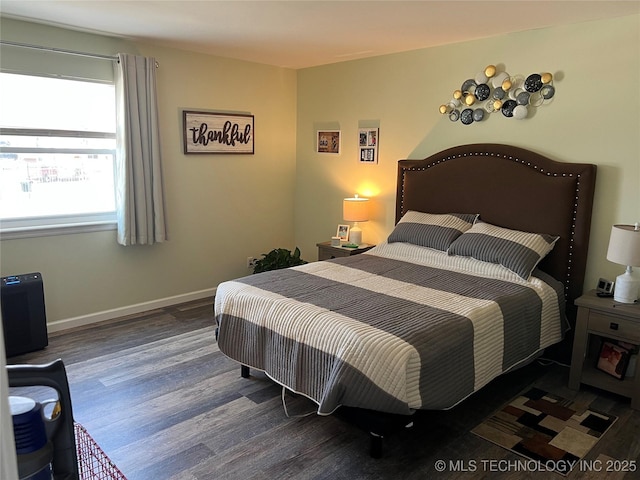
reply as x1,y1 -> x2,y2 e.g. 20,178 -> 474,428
0,19 -> 296,322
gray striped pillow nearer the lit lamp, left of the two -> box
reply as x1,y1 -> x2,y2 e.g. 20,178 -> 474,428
387,210 -> 478,252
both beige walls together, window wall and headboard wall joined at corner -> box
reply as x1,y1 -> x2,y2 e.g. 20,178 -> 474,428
0,16 -> 640,328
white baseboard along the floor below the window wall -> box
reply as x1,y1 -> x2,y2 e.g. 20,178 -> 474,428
47,288 -> 216,332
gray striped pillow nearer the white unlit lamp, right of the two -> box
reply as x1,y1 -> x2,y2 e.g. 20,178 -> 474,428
447,220 -> 560,280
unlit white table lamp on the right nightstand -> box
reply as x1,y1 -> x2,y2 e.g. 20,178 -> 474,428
607,223 -> 640,303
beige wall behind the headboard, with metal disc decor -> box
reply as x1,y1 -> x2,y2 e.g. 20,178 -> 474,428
295,15 -> 640,288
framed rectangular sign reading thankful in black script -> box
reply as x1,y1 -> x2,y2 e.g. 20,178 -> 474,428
183,110 -> 254,154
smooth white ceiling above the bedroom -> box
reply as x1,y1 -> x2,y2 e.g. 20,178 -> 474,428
0,0 -> 640,69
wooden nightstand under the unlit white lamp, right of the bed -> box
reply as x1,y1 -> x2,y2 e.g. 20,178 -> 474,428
569,290 -> 640,410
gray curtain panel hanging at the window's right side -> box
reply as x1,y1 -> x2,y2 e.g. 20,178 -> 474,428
115,53 -> 167,245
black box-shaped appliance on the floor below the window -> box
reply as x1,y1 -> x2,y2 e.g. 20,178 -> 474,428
0,272 -> 49,357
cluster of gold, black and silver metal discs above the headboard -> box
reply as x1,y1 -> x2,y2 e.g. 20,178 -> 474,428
439,65 -> 556,125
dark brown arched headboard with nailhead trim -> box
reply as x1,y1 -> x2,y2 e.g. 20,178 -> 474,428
396,144 -> 596,318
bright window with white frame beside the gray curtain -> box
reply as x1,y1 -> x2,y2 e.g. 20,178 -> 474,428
0,73 -> 116,237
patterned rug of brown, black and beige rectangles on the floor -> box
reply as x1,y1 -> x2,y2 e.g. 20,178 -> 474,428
472,388 -> 617,475
